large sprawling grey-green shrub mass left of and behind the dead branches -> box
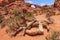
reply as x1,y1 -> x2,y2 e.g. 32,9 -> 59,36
1,8 -> 33,32
